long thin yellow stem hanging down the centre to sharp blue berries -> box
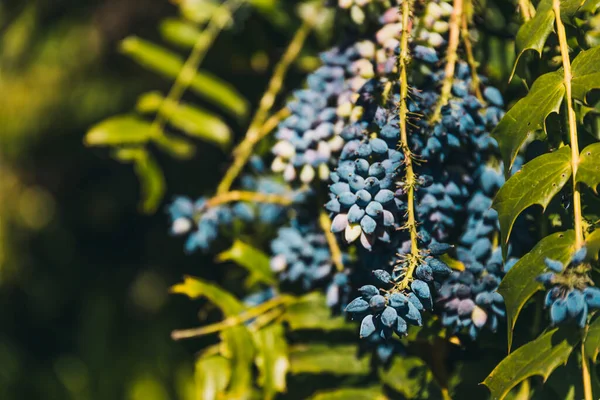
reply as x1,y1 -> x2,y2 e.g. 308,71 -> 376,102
397,1 -> 420,290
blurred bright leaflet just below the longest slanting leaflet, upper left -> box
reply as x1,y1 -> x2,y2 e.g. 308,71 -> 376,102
136,92 -> 231,149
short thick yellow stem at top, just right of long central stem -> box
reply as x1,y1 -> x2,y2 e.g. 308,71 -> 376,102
431,0 -> 463,123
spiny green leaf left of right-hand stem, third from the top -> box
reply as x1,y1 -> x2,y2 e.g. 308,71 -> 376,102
492,146 -> 571,249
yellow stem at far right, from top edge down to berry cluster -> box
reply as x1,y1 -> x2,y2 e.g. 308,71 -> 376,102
552,0 -> 583,248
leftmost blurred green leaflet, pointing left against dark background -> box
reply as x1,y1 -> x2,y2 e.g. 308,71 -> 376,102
83,115 -> 151,146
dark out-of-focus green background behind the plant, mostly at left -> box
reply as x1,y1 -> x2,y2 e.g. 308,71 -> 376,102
0,0 -> 518,400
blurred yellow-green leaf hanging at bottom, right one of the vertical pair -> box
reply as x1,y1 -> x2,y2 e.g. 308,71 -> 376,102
253,324 -> 289,399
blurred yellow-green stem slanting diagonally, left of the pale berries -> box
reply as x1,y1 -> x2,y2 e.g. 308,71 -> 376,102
217,18 -> 318,194
